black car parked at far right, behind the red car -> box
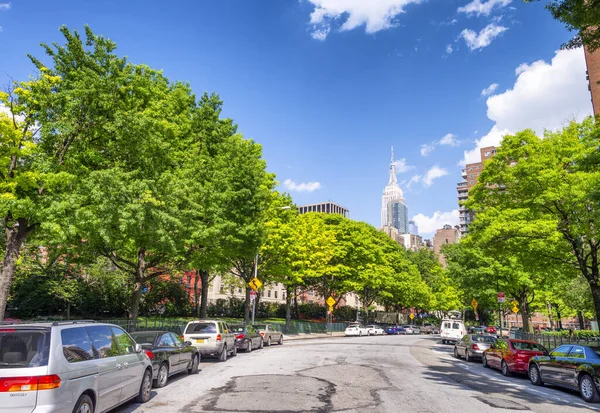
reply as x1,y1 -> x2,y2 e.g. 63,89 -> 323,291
529,344 -> 600,403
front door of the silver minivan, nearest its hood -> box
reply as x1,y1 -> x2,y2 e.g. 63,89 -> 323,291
111,327 -> 145,401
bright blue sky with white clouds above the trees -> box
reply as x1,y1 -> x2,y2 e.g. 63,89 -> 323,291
0,0 -> 591,235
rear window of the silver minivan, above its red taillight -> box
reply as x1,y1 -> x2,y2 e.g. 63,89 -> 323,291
0,328 -> 50,369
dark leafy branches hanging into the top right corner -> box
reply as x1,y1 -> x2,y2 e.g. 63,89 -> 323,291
524,0 -> 600,51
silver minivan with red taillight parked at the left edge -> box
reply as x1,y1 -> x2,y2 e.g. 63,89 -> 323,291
0,321 -> 152,413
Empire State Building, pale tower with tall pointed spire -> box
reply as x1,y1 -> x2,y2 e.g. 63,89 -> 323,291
381,147 -> 408,234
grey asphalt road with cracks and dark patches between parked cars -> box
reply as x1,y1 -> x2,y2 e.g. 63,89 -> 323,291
111,336 -> 600,413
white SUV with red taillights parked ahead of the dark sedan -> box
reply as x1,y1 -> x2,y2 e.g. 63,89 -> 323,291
183,320 -> 237,361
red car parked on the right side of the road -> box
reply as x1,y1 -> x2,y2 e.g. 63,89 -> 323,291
481,339 -> 548,376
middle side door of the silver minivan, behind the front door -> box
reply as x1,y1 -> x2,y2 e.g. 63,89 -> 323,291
85,326 -> 123,412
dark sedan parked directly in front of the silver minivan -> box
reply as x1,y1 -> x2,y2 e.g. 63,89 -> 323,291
130,331 -> 200,388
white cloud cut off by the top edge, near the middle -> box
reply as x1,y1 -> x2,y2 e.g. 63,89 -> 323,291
308,0 -> 422,40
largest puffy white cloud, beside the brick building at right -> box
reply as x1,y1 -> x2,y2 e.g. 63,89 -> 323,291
463,49 -> 592,163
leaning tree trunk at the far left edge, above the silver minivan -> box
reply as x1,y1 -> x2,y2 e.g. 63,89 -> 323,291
0,217 -> 32,321
